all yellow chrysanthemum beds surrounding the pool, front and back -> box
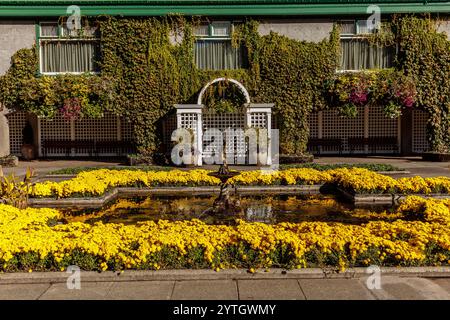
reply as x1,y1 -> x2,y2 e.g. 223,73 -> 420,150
0,168 -> 450,272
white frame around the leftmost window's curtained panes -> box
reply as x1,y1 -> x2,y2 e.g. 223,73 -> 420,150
36,20 -> 101,76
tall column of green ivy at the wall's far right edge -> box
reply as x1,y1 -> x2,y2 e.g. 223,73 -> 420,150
391,16 -> 450,152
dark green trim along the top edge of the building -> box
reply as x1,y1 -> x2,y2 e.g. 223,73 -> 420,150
0,2 -> 450,17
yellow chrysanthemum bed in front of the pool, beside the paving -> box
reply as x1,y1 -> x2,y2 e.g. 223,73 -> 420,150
0,197 -> 450,271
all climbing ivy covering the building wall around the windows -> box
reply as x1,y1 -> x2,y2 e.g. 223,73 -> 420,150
0,16 -> 450,155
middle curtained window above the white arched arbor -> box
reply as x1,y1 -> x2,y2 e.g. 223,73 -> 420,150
194,22 -> 246,70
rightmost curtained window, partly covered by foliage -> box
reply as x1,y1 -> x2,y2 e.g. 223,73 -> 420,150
340,20 -> 395,70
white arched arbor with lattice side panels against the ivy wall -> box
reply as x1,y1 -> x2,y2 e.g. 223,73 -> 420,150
175,78 -> 274,166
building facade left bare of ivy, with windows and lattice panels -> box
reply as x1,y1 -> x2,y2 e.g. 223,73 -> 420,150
0,0 -> 450,157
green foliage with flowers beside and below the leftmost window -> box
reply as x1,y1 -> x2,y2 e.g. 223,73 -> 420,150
0,48 -> 114,118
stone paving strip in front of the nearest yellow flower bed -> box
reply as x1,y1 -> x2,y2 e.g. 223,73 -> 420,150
0,276 -> 450,300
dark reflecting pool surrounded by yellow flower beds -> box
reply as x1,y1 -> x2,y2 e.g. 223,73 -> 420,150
61,195 -> 390,225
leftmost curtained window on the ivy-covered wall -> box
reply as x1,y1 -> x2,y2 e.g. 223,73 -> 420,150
39,22 -> 100,74
